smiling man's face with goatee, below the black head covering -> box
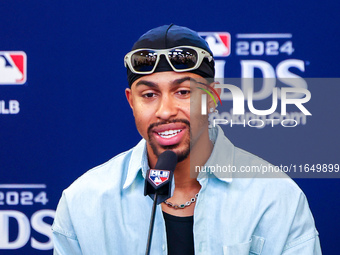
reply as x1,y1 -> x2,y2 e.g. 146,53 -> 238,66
126,71 -> 208,162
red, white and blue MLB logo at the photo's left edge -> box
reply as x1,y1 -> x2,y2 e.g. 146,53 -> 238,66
0,51 -> 27,85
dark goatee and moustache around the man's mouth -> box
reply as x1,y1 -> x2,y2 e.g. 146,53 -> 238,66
148,119 -> 191,162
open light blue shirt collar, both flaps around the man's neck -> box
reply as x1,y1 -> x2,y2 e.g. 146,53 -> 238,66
123,126 -> 234,189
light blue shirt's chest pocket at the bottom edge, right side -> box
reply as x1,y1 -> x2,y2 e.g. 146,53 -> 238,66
223,235 -> 265,255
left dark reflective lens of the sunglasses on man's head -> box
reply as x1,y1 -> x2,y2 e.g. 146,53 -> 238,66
131,50 -> 157,72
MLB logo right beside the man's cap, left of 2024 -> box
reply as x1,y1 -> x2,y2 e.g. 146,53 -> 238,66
198,32 -> 231,57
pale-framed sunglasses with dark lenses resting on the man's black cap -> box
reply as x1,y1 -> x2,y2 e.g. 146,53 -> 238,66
124,46 -> 213,74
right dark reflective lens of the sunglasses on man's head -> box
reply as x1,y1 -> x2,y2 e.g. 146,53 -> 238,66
168,47 -> 198,70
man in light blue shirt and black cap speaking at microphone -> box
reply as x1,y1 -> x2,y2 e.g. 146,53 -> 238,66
53,25 -> 321,255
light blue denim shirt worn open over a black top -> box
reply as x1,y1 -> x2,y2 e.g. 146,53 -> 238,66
52,127 -> 321,255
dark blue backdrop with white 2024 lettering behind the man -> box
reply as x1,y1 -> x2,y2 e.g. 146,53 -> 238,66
0,0 -> 340,254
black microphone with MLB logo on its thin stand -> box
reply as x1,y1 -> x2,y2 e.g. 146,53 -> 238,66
144,151 -> 177,255
